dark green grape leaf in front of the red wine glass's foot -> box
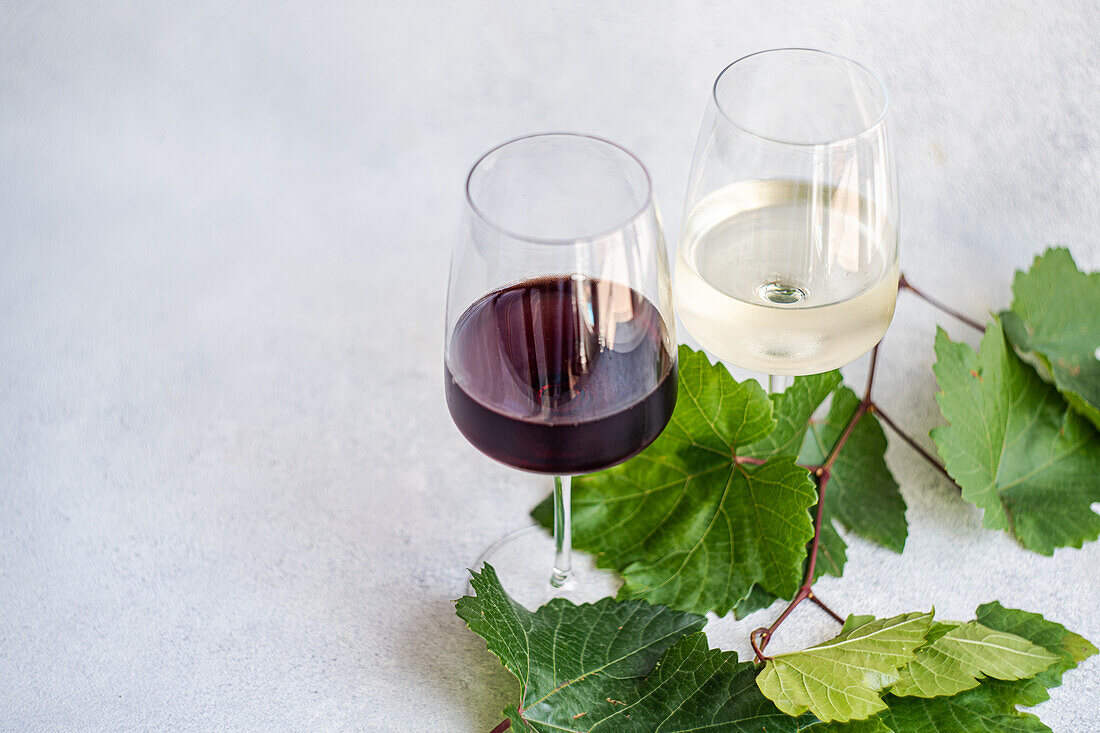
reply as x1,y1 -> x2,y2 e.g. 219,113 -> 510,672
457,565 -> 813,733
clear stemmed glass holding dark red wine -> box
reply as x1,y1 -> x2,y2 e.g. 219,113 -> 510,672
444,133 -> 677,594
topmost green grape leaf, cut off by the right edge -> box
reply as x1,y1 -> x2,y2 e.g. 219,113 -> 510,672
1001,248 -> 1100,428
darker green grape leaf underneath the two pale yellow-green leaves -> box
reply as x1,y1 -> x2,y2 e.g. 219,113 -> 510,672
809,601 -> 1097,733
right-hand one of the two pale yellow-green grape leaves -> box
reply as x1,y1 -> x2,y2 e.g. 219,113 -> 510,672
890,621 -> 1059,698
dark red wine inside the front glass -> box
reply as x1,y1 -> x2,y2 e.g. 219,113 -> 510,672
446,275 -> 677,474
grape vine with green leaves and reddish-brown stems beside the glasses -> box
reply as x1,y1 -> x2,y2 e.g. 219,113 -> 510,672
458,248 -> 1100,733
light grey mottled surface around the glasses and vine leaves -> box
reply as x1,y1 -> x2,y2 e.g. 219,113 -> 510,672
0,0 -> 1100,733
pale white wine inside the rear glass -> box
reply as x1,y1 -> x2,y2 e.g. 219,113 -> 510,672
675,179 -> 898,375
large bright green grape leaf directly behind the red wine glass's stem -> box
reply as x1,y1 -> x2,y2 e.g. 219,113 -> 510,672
532,346 -> 816,615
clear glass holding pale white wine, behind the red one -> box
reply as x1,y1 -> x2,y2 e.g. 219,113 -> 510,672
675,48 -> 899,391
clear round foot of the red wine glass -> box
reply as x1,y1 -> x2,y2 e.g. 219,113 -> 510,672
466,524 -> 620,611
